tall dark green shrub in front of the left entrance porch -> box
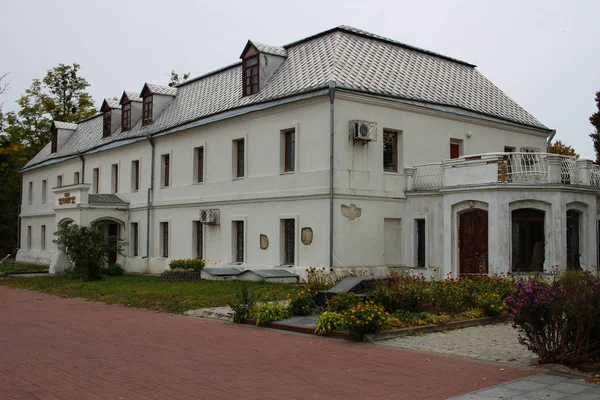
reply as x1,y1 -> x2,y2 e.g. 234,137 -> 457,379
53,223 -> 122,281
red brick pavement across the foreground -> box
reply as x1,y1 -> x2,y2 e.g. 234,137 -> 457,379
0,287 -> 534,400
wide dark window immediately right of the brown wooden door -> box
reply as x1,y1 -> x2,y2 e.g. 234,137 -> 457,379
511,208 -> 546,272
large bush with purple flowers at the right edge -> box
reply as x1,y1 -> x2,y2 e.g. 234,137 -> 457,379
506,271 -> 600,365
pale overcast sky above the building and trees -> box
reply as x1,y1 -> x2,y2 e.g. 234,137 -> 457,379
0,0 -> 600,158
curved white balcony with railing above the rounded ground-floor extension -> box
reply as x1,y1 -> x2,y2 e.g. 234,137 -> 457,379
405,153 -> 600,191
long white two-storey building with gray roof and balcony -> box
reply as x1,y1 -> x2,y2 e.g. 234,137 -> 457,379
17,26 -> 600,277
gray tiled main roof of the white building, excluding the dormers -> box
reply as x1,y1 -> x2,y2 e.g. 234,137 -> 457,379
26,26 -> 548,168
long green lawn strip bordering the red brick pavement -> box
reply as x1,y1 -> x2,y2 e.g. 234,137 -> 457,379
0,275 -> 298,314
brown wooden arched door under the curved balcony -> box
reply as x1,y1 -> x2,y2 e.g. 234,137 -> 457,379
458,210 -> 488,274
